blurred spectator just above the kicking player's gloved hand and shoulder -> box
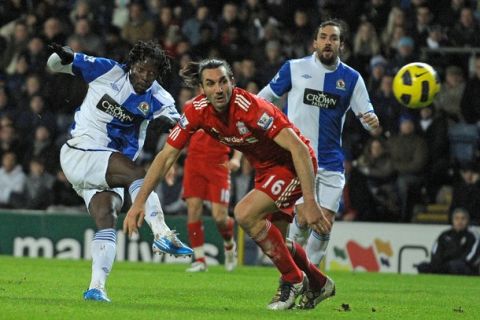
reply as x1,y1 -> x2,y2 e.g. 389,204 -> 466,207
67,18 -> 105,56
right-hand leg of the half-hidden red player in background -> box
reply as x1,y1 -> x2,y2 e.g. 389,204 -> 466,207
212,202 -> 237,271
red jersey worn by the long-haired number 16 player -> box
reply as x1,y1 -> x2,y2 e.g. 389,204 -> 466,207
167,88 -> 316,173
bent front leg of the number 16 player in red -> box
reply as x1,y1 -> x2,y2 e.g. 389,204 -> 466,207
234,189 -> 307,310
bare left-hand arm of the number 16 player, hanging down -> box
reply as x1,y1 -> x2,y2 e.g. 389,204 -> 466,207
123,143 -> 181,237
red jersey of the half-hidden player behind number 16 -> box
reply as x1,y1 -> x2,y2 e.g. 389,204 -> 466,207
187,130 -> 230,162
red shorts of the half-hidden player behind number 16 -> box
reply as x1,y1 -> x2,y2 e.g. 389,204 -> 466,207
183,157 -> 230,205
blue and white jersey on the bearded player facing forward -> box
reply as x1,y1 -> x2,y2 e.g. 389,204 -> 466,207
259,53 -> 373,172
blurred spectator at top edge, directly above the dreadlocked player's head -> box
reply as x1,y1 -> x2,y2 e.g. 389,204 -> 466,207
122,2 -> 155,45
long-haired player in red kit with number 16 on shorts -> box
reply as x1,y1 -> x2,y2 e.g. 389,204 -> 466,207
123,59 -> 335,310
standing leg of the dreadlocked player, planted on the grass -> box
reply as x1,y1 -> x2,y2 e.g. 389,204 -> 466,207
83,190 -> 123,302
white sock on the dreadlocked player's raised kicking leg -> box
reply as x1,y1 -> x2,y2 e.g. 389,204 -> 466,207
128,179 -> 170,238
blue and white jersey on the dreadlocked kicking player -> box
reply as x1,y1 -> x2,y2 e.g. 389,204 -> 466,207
69,53 -> 180,160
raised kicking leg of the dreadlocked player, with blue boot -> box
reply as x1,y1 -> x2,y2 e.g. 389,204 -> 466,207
105,152 -> 193,256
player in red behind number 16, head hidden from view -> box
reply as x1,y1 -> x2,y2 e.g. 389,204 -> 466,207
183,130 -> 241,272
